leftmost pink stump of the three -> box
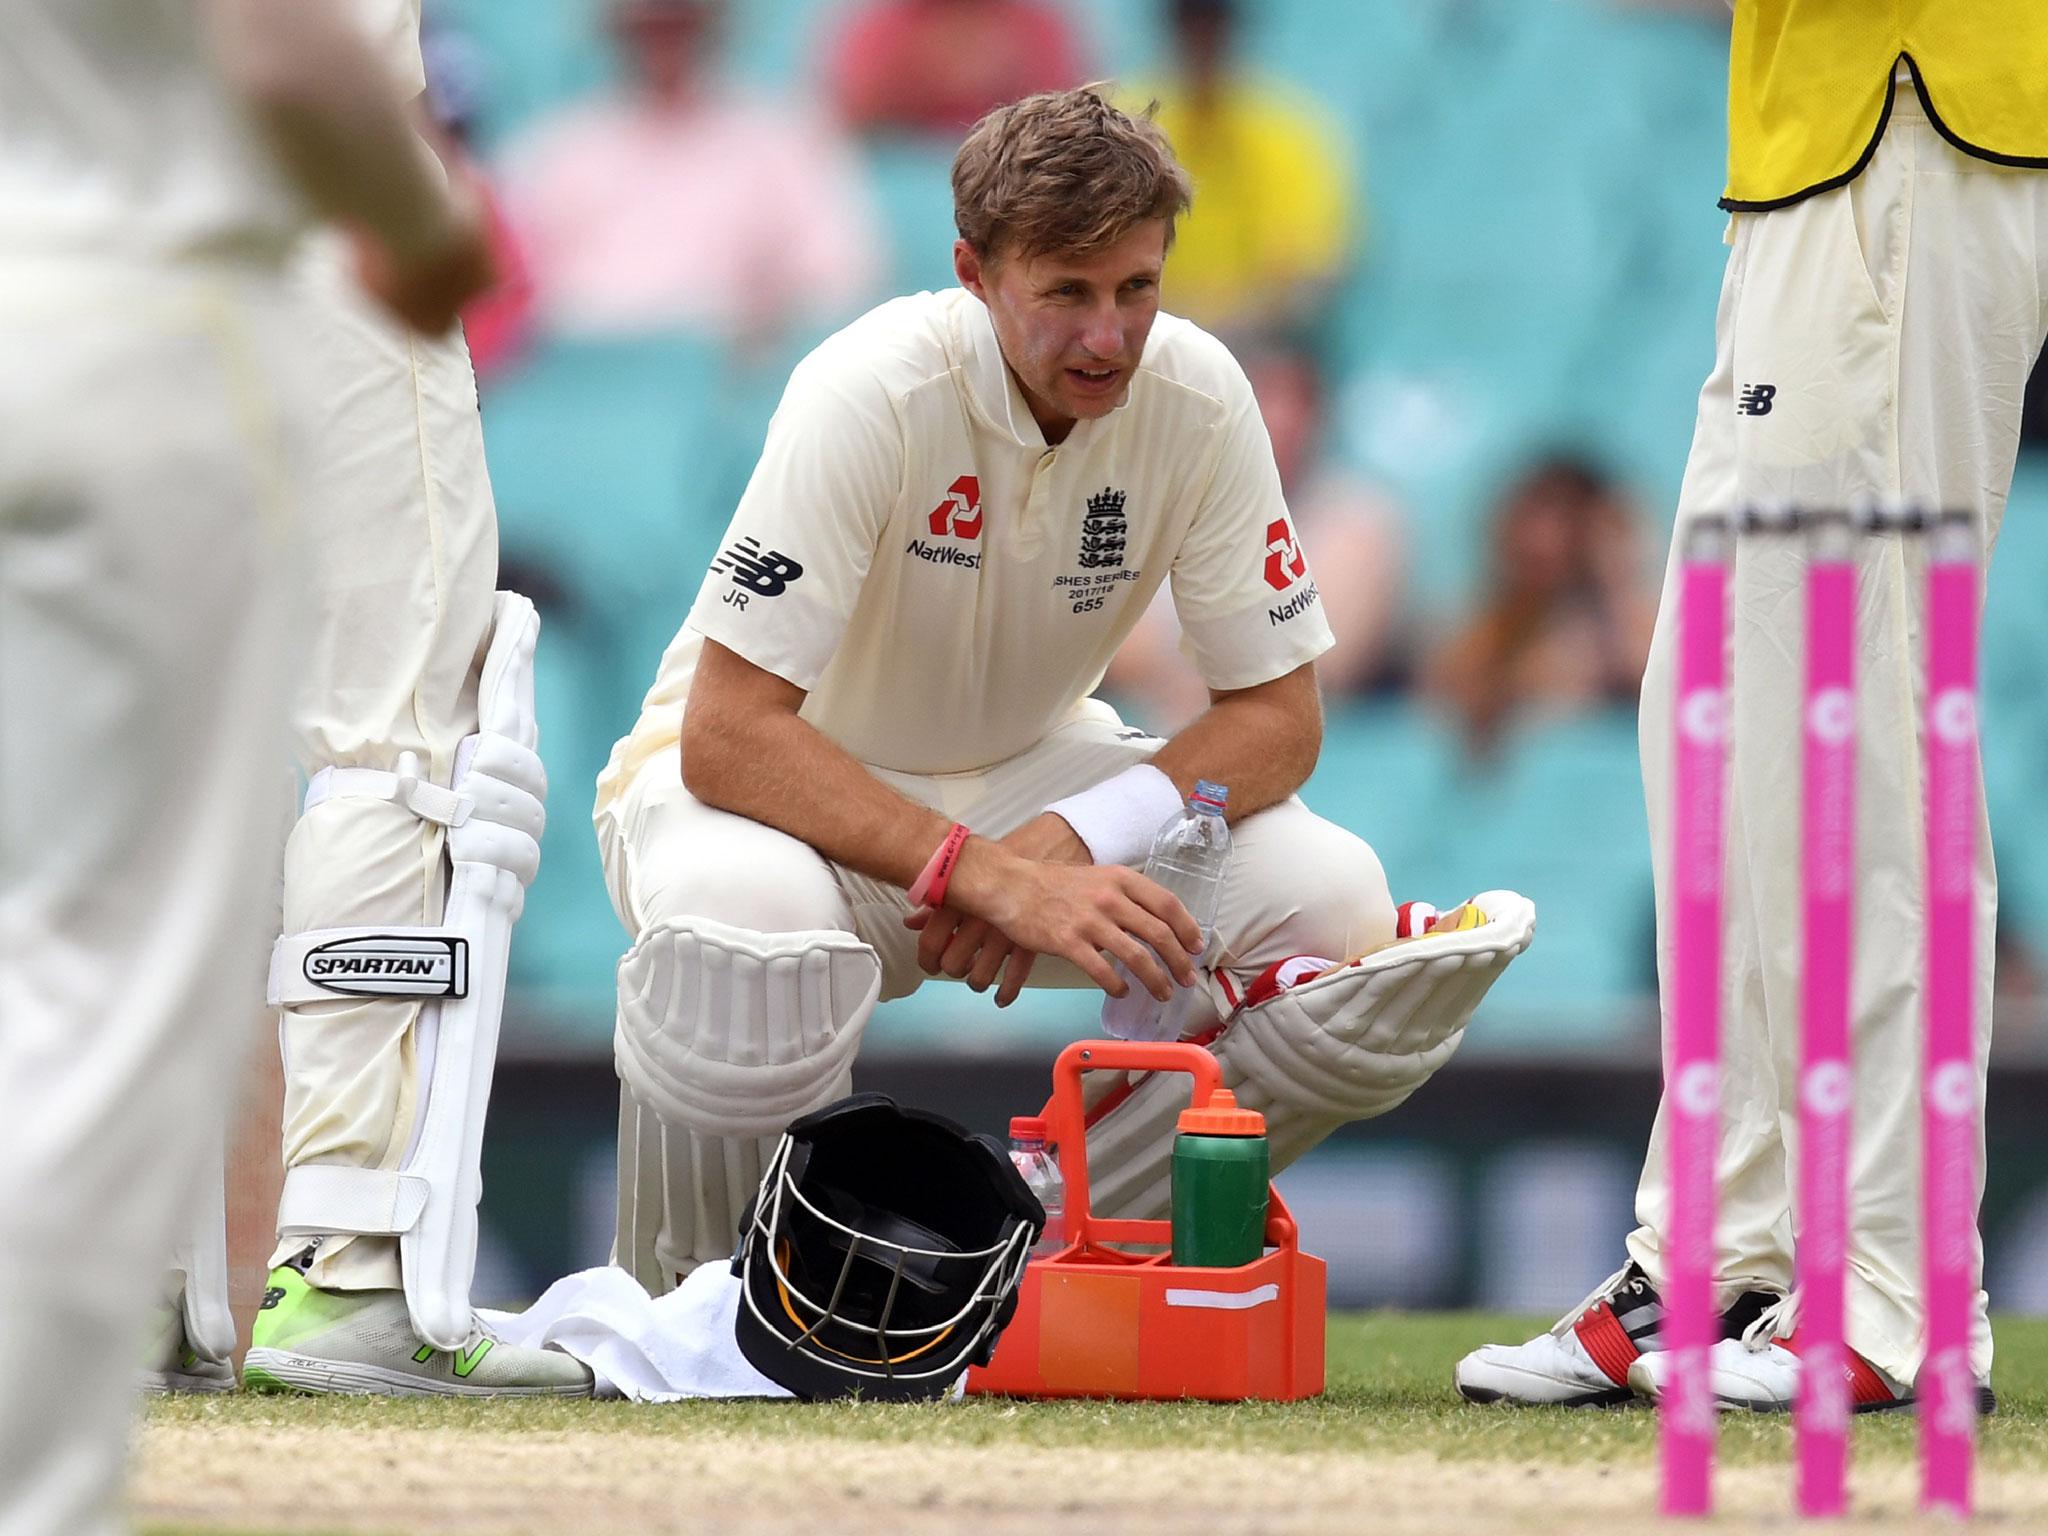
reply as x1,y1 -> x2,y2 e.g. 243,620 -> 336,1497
1659,518 -> 1729,1516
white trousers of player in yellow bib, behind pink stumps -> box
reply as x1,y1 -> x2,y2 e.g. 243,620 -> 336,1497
1628,88 -> 2048,1382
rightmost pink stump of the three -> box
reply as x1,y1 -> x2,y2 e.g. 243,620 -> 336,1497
1917,512 -> 1982,1516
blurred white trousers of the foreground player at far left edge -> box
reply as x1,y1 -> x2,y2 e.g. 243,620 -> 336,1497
0,256 -> 303,1536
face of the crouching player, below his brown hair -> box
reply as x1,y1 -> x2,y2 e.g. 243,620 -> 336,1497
952,219 -> 1165,442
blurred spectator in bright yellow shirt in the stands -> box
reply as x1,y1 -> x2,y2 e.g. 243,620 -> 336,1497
1130,0 -> 1358,338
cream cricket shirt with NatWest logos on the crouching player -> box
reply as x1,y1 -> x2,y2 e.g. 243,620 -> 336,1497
598,289 -> 1331,807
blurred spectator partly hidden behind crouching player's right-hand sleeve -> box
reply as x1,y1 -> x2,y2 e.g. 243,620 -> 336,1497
1106,348 -> 1407,731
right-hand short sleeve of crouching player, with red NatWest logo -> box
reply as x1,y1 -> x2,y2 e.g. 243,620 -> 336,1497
1174,373 -> 1335,690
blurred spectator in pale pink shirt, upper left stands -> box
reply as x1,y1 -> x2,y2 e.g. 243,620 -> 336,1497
504,0 -> 879,342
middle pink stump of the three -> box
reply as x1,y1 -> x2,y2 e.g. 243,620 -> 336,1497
1794,514 -> 1855,1516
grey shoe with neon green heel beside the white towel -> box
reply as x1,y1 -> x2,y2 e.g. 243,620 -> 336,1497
242,1266 -> 590,1397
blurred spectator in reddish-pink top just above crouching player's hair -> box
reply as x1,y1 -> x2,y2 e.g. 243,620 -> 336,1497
825,0 -> 1085,137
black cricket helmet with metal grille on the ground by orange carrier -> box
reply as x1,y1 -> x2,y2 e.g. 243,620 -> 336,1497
733,1094 -> 1044,1403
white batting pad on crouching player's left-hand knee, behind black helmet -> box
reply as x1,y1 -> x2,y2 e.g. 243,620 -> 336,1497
614,918 -> 883,1292
